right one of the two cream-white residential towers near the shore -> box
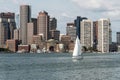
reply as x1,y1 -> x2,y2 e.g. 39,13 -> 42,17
97,19 -> 110,53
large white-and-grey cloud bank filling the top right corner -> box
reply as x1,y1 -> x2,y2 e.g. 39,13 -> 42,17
72,0 -> 120,18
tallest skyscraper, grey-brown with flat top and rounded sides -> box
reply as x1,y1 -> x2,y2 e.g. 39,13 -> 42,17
20,5 -> 31,44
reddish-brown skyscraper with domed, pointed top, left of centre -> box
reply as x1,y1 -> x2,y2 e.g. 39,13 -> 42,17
37,11 -> 49,40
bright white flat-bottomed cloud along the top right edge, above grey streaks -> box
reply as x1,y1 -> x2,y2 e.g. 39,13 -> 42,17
72,0 -> 120,9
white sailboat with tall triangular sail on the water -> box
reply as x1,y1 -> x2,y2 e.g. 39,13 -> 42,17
72,36 -> 82,59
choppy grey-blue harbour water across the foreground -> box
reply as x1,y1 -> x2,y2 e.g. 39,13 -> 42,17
0,53 -> 120,80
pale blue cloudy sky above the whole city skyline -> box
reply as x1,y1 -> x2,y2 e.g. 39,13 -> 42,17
0,0 -> 120,41
